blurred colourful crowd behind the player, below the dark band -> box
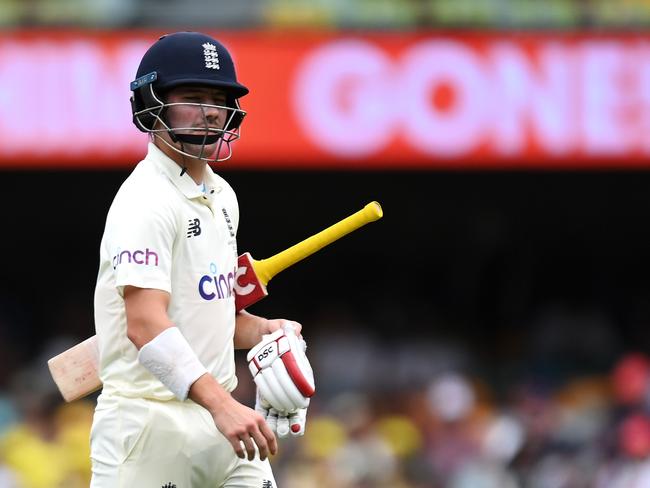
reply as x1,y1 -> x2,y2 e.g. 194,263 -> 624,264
0,306 -> 650,488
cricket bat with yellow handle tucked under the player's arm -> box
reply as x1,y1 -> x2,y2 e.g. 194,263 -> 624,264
47,202 -> 383,402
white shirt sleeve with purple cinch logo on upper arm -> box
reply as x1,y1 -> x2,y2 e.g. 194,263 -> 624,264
107,197 -> 176,295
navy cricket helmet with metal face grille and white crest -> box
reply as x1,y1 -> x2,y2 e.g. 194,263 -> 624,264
131,32 -> 248,166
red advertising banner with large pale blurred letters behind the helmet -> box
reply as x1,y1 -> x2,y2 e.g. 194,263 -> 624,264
0,31 -> 650,168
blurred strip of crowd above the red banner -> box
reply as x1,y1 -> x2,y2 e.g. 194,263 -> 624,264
0,0 -> 650,29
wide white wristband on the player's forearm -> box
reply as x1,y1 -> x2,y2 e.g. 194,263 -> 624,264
138,327 -> 208,400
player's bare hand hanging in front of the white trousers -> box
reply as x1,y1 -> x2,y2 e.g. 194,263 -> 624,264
211,395 -> 278,461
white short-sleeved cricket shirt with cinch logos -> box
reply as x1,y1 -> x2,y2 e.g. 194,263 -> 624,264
95,143 -> 239,400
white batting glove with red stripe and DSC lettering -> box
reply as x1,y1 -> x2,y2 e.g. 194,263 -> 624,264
247,321 -> 315,414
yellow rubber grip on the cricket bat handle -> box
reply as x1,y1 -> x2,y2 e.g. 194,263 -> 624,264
248,202 -> 384,286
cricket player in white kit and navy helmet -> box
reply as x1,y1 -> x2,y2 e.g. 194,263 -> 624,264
91,32 -> 313,488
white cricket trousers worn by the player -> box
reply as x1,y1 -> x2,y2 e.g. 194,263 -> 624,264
90,395 -> 277,488
